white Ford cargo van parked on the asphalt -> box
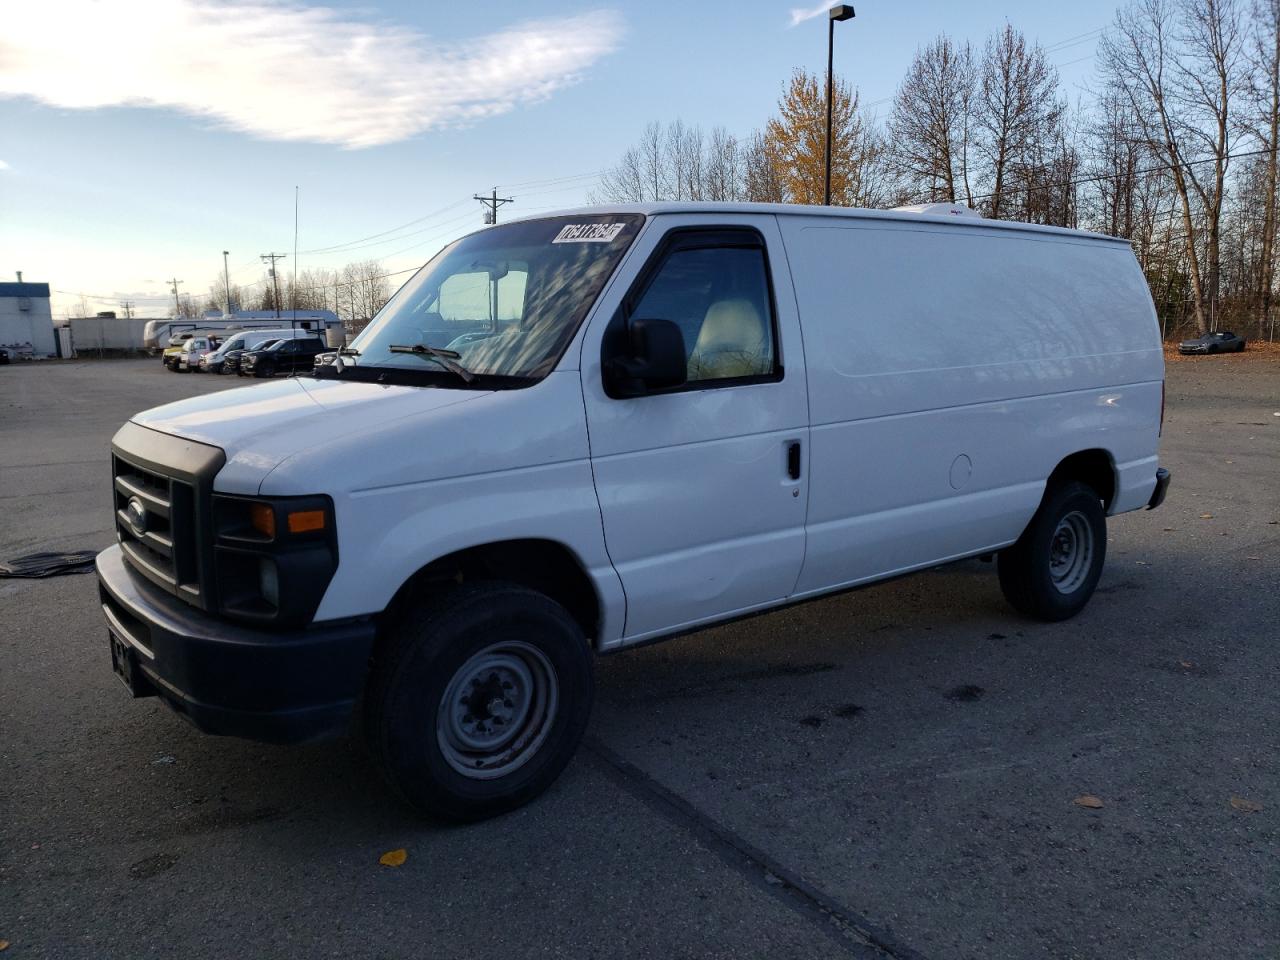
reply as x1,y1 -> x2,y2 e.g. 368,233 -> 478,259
97,204 -> 1169,819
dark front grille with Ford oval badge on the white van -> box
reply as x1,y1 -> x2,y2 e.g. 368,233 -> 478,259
111,424 -> 224,609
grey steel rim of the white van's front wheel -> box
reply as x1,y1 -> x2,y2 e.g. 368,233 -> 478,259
435,640 -> 559,780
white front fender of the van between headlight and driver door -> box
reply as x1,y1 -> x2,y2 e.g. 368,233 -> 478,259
271,371 -> 625,637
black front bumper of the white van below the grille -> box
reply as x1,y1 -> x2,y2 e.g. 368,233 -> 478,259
97,547 -> 374,744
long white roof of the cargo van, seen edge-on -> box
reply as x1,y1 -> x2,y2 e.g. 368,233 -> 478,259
507,201 -> 1129,246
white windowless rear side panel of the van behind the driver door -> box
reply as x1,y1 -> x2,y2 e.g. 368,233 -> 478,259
780,216 -> 1164,594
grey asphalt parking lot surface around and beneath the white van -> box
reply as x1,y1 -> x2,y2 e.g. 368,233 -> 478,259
0,357 -> 1280,960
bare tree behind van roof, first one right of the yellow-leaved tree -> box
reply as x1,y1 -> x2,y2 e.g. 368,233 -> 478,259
888,36 -> 975,202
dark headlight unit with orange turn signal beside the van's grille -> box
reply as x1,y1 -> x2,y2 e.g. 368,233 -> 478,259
214,494 -> 338,626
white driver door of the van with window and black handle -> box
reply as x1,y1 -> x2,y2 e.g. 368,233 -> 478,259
581,215 -> 809,641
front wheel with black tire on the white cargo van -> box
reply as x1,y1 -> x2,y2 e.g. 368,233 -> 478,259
365,582 -> 594,822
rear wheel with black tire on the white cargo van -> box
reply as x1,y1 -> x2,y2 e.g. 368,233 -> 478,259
997,480 -> 1107,621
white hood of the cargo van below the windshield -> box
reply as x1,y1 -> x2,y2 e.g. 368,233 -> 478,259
133,378 -> 490,494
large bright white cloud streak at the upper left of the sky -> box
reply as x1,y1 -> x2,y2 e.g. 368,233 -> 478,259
0,0 -> 622,147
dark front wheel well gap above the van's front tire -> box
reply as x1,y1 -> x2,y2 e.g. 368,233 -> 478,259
387,540 -> 600,644
